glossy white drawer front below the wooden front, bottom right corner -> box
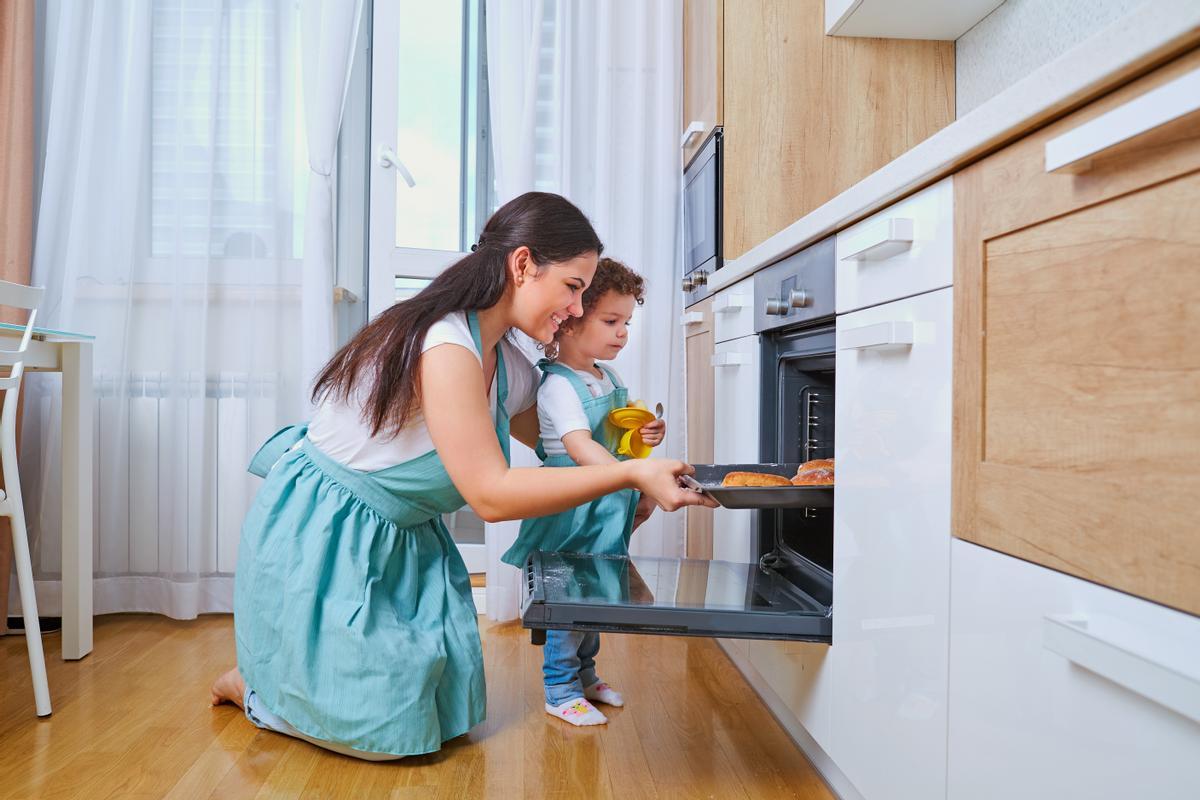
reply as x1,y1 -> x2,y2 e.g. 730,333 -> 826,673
948,541 -> 1200,800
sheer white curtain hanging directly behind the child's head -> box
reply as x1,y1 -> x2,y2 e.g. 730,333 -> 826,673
486,0 -> 685,620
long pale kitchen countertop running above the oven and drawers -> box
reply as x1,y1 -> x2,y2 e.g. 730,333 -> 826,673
708,0 -> 1200,291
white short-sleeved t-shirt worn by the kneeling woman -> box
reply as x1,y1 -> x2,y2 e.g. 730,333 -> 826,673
308,312 -> 541,471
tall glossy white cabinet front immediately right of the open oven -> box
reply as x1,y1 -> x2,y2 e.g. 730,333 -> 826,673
830,288 -> 953,800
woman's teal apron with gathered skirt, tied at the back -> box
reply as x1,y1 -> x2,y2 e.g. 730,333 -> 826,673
234,312 -> 509,756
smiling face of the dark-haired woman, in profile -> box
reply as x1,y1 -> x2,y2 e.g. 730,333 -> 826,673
511,247 -> 600,344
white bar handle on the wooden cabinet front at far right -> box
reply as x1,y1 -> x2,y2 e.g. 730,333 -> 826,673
1045,70 -> 1200,173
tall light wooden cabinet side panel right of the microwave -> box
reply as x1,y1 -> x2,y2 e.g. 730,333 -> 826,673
724,0 -> 954,260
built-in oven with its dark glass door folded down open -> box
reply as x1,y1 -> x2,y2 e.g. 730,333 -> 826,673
521,239 -> 836,644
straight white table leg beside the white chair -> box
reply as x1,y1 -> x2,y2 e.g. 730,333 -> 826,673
59,342 -> 92,661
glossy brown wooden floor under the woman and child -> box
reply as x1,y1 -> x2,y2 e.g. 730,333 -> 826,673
0,614 -> 832,800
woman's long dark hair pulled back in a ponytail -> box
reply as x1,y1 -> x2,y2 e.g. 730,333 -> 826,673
312,192 -> 604,435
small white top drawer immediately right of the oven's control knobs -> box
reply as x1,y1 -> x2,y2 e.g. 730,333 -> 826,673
836,178 -> 954,314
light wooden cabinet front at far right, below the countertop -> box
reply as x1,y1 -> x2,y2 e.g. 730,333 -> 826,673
953,47 -> 1200,614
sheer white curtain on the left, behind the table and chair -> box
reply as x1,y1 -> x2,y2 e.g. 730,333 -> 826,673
12,0 -> 361,618
